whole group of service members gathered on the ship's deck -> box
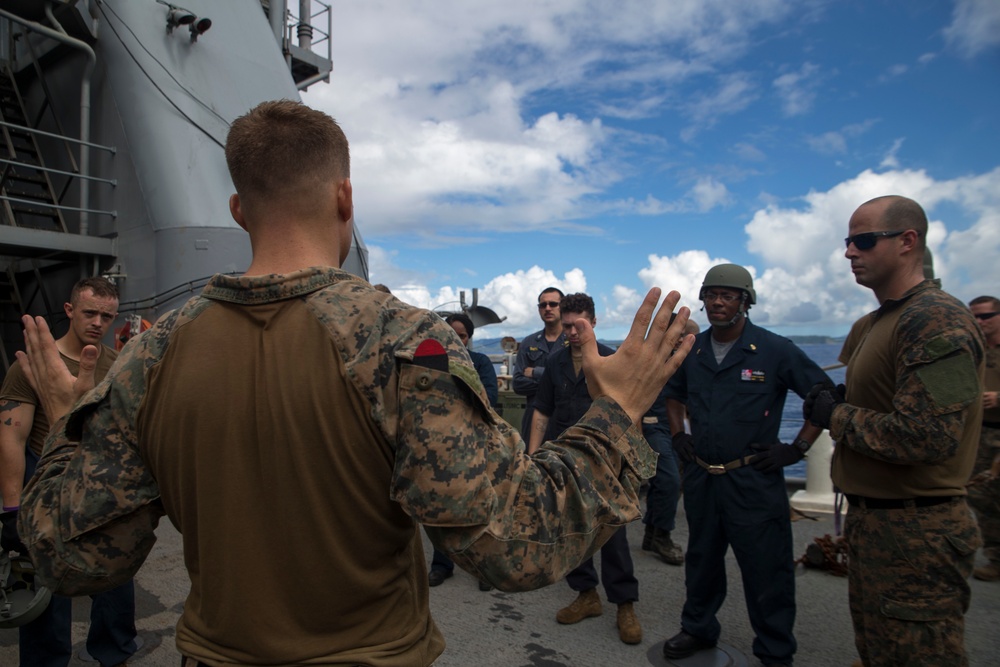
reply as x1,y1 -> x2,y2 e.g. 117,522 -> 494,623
0,100 -> 1000,667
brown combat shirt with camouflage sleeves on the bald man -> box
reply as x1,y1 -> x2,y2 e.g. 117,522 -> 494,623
830,280 -> 985,498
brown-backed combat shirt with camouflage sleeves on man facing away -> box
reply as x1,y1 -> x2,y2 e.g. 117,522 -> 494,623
20,268 -> 655,665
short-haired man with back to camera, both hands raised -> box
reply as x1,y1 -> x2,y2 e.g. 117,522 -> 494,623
11,100 -> 691,667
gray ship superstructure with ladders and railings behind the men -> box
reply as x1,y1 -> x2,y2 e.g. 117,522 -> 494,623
0,0 -> 367,369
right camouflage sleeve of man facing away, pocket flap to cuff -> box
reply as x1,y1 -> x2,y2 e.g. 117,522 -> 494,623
392,350 -> 656,590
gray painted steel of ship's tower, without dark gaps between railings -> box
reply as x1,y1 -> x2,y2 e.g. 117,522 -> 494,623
0,0 -> 367,341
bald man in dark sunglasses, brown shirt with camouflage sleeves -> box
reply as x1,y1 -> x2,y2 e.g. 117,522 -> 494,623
804,196 -> 985,667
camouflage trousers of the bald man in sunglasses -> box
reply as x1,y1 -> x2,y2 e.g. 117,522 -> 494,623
845,498 -> 981,667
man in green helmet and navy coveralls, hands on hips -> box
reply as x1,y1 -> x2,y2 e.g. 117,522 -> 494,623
663,264 -> 829,665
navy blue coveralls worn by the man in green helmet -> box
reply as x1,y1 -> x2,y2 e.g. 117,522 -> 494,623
666,320 -> 829,664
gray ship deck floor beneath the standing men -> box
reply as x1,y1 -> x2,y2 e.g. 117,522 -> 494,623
0,498 -> 1000,667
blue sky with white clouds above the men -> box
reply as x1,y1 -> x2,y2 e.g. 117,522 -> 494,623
303,0 -> 1000,338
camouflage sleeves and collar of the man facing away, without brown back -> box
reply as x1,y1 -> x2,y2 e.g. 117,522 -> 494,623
20,268 -> 655,596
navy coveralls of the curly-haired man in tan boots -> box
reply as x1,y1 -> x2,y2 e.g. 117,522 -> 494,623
535,343 -> 639,604
